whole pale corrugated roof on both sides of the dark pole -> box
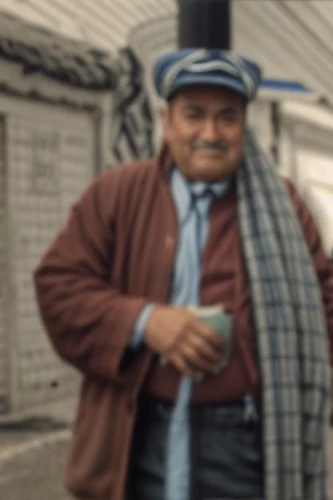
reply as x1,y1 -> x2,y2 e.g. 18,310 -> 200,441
0,0 -> 333,97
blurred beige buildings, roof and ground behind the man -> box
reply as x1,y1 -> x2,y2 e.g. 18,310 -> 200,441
0,0 -> 333,500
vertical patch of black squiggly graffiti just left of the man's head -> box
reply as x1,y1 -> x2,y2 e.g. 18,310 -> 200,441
111,47 -> 154,163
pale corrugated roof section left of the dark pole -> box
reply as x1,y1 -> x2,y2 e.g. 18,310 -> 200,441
0,0 -> 176,50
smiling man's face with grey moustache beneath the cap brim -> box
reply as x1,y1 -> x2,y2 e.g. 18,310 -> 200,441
163,85 -> 245,182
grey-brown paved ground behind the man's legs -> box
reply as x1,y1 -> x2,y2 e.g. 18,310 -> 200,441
0,401 -> 333,500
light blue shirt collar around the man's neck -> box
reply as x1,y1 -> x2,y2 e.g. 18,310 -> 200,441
170,167 -> 231,224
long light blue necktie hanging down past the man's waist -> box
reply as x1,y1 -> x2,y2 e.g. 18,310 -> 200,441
165,184 -> 214,500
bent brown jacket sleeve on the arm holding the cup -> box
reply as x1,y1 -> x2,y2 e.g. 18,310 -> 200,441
34,170 -> 148,383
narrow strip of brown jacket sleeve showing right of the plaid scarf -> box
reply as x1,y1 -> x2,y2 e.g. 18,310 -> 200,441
284,179 -> 333,366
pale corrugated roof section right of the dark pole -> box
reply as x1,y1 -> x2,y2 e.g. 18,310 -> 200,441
233,0 -> 333,97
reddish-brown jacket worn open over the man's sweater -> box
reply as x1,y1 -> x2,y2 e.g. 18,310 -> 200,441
35,153 -> 333,500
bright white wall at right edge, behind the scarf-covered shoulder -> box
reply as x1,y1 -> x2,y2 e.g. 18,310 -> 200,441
281,102 -> 333,257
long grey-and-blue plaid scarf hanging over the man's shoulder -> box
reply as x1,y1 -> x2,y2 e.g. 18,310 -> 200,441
237,133 -> 329,500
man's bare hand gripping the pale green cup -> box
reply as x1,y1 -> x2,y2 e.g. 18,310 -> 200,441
145,306 -> 224,376
